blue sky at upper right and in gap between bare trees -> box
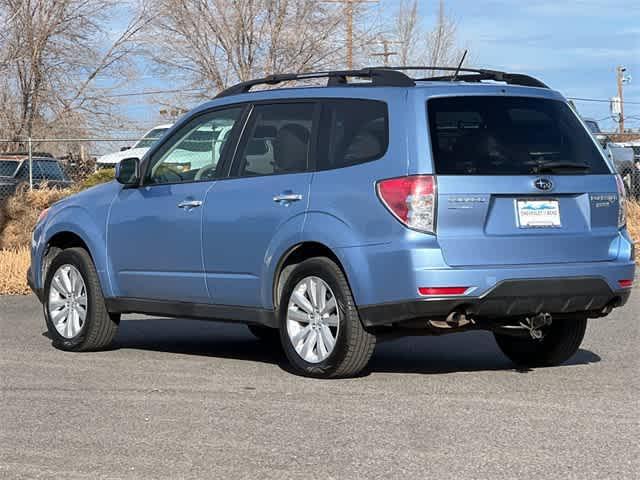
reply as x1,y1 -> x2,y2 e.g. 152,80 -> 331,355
117,0 -> 640,130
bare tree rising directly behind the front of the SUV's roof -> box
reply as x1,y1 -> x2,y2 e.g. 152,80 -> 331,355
146,0 -> 341,94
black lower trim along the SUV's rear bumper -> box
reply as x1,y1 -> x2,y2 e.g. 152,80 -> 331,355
359,277 -> 630,327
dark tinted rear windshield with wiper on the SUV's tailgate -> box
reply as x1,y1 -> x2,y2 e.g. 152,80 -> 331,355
427,96 -> 610,175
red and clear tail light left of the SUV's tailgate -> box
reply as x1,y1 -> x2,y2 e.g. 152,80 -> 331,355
377,175 -> 436,233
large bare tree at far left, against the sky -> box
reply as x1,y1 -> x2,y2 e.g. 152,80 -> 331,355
0,0 -> 149,150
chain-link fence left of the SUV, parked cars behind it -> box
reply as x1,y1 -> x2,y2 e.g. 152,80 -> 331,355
0,138 -> 144,202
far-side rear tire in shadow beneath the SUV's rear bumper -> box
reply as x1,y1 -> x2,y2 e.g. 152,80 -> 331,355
494,316 -> 587,367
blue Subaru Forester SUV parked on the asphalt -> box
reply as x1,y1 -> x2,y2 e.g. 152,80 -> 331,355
29,67 -> 635,377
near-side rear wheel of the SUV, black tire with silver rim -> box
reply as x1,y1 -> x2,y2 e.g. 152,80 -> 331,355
278,257 -> 376,378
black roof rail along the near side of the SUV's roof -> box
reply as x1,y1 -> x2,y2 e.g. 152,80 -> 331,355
216,67 -> 415,98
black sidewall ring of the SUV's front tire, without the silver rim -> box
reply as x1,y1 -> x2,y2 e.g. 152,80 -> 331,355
42,249 -> 96,350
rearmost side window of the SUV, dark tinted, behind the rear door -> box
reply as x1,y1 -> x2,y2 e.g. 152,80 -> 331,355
318,100 -> 389,170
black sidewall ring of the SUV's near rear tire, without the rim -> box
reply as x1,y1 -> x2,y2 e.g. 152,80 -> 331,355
278,258 -> 360,376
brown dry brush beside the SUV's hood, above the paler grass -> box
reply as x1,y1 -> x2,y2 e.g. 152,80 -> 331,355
0,186 -> 77,249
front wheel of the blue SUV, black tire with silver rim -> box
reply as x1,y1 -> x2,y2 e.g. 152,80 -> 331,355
43,248 -> 120,352
